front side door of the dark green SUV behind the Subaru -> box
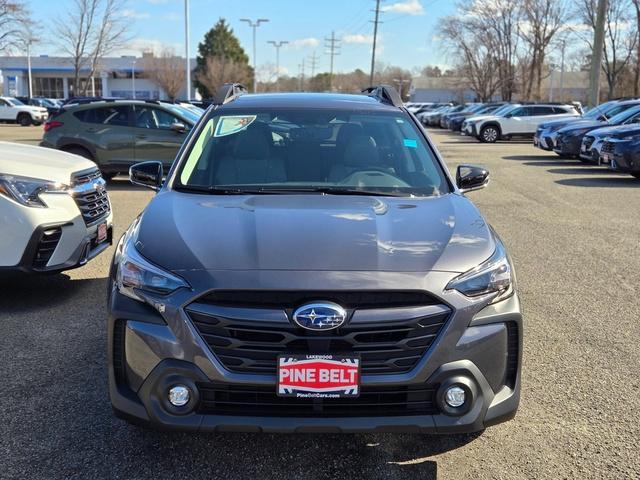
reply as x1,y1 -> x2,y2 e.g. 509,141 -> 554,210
133,104 -> 188,168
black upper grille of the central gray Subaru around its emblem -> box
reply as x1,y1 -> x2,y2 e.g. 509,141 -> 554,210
187,292 -> 450,375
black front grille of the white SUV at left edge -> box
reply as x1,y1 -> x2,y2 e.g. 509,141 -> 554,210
71,169 -> 111,226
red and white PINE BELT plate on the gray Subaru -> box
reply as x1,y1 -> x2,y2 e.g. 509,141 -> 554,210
277,354 -> 360,398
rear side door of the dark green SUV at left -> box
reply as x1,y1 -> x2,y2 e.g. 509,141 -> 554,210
79,105 -> 135,168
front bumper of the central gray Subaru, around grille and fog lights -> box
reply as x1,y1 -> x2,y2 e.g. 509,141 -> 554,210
108,272 -> 522,433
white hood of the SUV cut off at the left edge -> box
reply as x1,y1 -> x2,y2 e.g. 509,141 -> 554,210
0,142 -> 96,184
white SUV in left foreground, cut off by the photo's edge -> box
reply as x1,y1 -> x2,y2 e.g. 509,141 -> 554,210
0,142 -> 113,276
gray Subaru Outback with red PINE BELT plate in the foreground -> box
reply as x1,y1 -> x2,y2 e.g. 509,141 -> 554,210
108,85 -> 522,433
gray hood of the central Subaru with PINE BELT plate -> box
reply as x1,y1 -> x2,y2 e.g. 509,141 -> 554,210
136,191 -> 495,272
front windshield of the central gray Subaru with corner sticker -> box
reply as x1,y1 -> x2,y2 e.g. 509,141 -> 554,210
174,109 -> 450,196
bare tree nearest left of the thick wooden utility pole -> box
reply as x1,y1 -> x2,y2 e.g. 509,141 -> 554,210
519,0 -> 568,100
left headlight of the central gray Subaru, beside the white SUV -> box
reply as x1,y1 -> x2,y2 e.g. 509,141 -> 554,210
115,220 -> 189,302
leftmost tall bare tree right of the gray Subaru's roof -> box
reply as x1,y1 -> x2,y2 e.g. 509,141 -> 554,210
440,16 -> 500,101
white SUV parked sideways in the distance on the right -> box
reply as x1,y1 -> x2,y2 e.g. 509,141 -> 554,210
462,104 -> 580,143
